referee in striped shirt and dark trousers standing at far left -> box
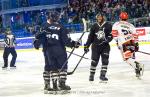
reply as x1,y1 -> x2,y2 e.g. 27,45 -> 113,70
2,31 -> 17,69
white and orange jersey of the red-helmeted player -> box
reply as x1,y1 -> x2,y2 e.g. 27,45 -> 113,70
112,21 -> 138,46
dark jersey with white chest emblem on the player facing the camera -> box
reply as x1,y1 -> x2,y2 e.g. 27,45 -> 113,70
86,22 -> 113,46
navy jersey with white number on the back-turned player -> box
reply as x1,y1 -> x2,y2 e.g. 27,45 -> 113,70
36,23 -> 73,55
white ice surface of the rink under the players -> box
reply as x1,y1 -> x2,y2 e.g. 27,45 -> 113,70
0,42 -> 150,97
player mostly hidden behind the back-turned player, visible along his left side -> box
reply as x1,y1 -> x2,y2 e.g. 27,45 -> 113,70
31,23 -> 54,94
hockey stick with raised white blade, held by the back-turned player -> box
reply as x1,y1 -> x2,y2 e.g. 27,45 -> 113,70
59,18 -> 87,72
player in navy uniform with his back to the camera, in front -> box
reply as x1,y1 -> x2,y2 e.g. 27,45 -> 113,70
34,12 -> 80,91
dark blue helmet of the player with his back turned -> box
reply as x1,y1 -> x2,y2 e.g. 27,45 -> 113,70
47,11 -> 60,22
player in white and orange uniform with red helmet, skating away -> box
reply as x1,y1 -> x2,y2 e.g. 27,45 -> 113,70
112,12 -> 143,77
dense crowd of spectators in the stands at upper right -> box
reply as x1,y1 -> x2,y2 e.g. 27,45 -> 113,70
64,0 -> 150,26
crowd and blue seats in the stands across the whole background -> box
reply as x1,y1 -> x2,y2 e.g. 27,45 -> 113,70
0,0 -> 150,37
